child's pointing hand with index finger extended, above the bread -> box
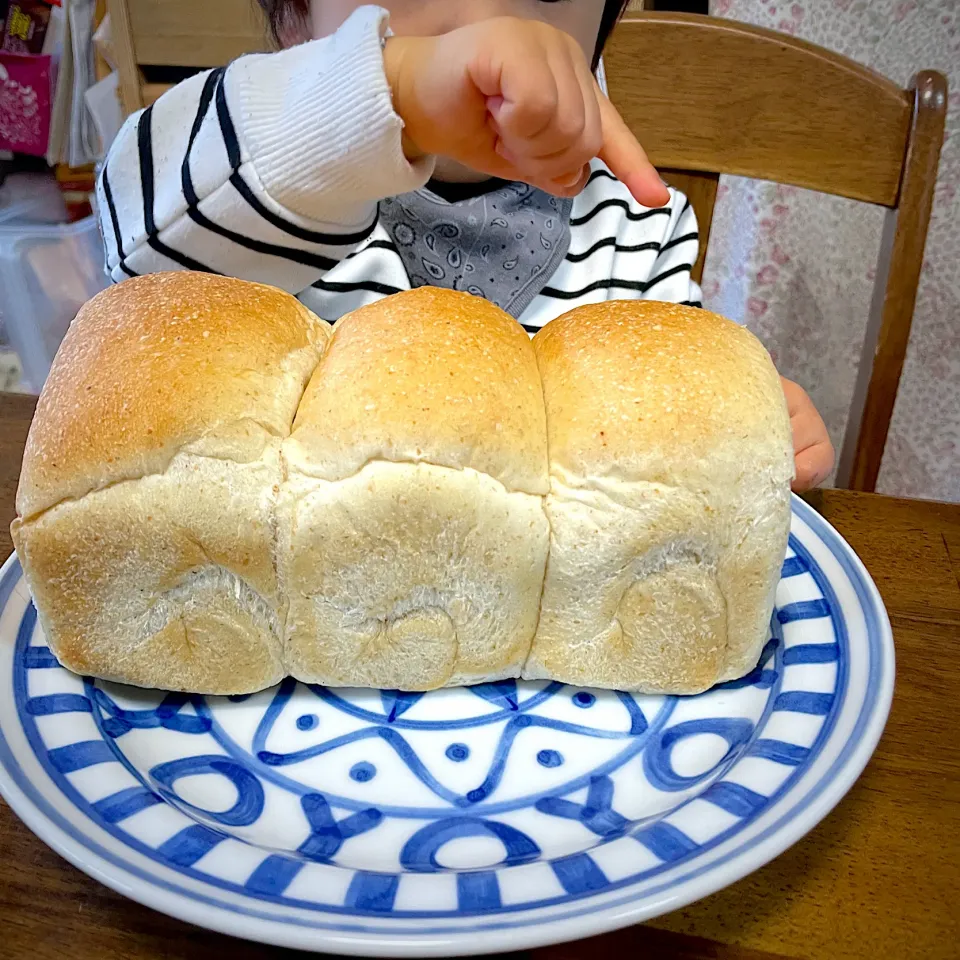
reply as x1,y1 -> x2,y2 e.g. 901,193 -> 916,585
384,17 -> 669,207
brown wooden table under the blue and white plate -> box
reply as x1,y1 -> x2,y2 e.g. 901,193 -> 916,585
0,395 -> 960,960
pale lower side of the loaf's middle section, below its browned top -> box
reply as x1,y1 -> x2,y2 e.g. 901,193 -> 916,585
278,460 -> 548,690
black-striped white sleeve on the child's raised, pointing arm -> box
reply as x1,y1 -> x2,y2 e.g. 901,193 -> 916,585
97,7 -> 431,293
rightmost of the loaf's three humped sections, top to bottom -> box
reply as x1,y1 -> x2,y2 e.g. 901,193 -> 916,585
523,301 -> 793,693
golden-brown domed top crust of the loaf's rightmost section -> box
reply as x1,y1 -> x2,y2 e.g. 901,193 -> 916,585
533,300 -> 786,483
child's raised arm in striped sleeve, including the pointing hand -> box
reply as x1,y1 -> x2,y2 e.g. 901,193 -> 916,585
99,7 -> 666,292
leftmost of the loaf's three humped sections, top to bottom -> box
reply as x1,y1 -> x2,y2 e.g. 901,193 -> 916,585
13,273 -> 329,693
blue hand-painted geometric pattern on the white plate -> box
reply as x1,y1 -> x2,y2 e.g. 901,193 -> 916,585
3,544 -> 832,917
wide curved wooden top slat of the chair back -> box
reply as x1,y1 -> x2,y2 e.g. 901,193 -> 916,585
604,13 -> 912,207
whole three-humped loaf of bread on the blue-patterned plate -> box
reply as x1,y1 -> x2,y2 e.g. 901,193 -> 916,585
13,273 -> 793,694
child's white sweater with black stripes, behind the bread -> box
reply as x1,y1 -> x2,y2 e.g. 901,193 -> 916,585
98,7 -> 700,330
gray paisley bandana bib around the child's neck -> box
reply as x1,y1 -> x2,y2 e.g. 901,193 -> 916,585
380,183 -> 573,317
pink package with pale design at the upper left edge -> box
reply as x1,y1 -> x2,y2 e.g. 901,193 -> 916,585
0,51 -> 51,156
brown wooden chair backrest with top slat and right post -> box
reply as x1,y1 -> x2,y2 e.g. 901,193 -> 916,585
604,13 -> 947,490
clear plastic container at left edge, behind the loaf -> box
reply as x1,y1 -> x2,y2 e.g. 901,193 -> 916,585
0,216 -> 108,393
